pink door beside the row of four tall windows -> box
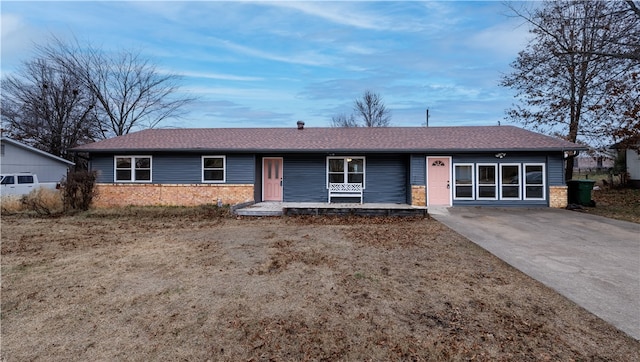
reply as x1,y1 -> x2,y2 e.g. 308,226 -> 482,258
427,157 -> 451,206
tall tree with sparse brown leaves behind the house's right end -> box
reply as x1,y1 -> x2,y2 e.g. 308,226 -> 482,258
501,0 -> 639,179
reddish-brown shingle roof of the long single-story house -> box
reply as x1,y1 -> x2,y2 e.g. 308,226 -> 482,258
73,126 -> 586,152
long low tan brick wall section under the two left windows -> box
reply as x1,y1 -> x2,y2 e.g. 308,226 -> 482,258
93,184 -> 253,208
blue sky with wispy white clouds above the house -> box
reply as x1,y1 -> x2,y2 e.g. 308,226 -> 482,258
0,1 -> 528,127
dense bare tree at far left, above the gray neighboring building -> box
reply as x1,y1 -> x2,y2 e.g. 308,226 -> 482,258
2,59 -> 97,159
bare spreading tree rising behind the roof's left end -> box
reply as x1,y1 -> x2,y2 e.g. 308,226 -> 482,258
37,37 -> 193,138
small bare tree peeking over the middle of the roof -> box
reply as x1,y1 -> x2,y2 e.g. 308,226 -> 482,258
331,90 -> 391,127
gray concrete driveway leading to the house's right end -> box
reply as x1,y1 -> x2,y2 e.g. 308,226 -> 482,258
429,207 -> 640,340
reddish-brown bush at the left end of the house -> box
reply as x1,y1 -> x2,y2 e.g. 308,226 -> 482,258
62,171 -> 96,211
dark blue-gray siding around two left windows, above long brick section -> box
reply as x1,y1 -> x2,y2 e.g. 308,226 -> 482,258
91,154 -> 255,184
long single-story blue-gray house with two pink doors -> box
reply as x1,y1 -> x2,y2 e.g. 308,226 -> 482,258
73,124 -> 585,207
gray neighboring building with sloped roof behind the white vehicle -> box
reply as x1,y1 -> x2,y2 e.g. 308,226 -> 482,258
0,137 -> 74,183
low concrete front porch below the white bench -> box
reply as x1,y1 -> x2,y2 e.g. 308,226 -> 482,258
234,202 -> 427,217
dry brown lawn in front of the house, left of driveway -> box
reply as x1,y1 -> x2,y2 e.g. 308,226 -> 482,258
1,208 -> 640,361
